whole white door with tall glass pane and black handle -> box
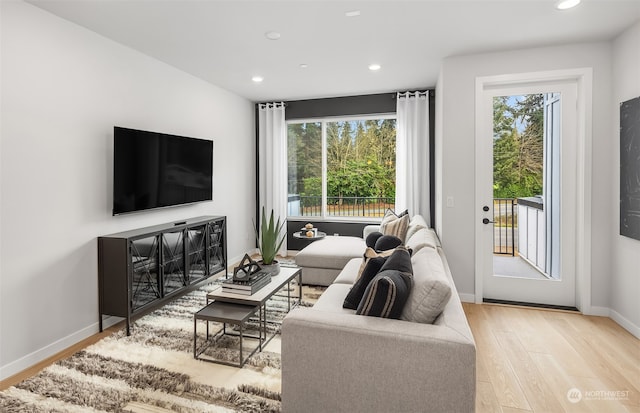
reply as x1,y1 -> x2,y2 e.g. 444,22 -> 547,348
476,81 -> 578,307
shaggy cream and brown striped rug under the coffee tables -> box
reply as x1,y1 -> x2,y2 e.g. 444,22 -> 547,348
0,283 -> 323,413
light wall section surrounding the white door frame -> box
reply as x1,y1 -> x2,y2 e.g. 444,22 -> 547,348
436,42 -> 613,307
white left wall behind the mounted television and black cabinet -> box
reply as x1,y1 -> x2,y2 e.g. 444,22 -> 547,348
0,1 -> 255,378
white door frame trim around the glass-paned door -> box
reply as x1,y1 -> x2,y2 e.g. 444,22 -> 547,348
474,68 -> 593,314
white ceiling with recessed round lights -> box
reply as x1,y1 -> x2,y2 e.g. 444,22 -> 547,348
29,0 -> 640,101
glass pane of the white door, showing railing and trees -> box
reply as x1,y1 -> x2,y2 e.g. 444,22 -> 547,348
493,93 -> 552,279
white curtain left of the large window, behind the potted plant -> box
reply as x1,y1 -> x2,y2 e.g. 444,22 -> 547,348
258,102 -> 287,256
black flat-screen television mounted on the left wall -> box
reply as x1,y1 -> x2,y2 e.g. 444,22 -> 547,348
113,126 -> 213,215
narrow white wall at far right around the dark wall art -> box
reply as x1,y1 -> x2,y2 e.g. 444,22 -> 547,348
610,21 -> 640,337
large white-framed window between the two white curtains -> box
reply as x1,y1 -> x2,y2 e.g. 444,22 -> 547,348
287,115 -> 396,218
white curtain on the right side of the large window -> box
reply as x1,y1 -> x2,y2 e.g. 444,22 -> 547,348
396,91 -> 431,226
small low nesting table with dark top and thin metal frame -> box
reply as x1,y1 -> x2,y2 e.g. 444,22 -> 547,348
193,301 -> 264,368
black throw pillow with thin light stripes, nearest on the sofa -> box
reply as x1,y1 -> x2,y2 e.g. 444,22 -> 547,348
356,268 -> 412,319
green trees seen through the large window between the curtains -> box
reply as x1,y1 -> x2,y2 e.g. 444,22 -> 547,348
288,119 -> 396,203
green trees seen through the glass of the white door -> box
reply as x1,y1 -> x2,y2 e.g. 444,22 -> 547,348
493,94 -> 544,198
